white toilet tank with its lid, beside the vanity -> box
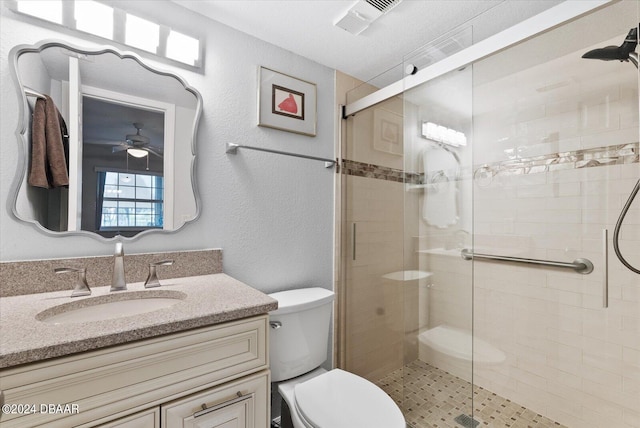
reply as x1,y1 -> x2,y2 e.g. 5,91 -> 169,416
269,288 -> 334,382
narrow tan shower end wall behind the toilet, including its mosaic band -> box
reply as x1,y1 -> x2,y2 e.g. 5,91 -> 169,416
339,88 -> 404,383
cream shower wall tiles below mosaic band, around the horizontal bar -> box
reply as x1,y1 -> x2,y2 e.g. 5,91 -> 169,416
474,164 -> 640,427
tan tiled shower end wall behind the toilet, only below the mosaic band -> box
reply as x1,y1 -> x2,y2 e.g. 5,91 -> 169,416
344,175 -> 404,380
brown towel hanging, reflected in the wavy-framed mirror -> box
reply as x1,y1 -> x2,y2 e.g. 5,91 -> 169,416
28,96 -> 69,189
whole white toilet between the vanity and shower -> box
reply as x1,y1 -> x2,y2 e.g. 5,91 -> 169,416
269,288 -> 406,428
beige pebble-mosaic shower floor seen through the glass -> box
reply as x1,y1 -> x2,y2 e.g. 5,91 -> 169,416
376,360 -> 567,428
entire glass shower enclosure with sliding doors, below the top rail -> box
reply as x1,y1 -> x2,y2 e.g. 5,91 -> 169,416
340,1 -> 640,428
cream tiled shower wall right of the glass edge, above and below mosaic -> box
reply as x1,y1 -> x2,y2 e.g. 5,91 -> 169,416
473,19 -> 640,428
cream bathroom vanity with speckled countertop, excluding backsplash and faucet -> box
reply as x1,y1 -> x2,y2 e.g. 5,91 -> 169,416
0,274 -> 277,428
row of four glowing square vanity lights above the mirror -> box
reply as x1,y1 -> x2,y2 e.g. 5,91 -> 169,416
9,0 -> 203,67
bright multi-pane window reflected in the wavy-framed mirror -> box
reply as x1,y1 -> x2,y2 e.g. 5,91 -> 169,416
96,171 -> 164,230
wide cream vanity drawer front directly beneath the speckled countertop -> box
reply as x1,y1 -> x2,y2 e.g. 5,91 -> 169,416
0,315 -> 268,428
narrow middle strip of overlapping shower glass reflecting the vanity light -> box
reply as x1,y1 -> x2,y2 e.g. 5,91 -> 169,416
403,38 -> 473,428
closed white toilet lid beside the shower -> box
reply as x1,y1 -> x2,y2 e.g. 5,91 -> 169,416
295,369 -> 406,428
